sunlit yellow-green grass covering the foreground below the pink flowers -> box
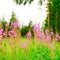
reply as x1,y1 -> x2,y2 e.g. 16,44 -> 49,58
0,38 -> 60,60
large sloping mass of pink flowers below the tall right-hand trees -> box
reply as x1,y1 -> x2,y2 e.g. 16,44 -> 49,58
33,24 -> 60,41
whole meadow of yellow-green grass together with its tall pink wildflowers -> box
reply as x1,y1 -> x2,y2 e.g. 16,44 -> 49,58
0,18 -> 60,60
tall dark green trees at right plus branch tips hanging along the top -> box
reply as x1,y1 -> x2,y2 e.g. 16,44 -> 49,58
14,0 -> 60,33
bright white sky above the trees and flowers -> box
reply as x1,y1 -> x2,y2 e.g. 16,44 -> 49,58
0,0 -> 47,26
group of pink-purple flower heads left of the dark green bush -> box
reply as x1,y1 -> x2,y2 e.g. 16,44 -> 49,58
0,22 -> 20,37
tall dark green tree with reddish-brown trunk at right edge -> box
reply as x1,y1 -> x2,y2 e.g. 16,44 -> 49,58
45,0 -> 60,33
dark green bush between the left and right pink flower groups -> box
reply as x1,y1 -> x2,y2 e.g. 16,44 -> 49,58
21,21 -> 34,37
